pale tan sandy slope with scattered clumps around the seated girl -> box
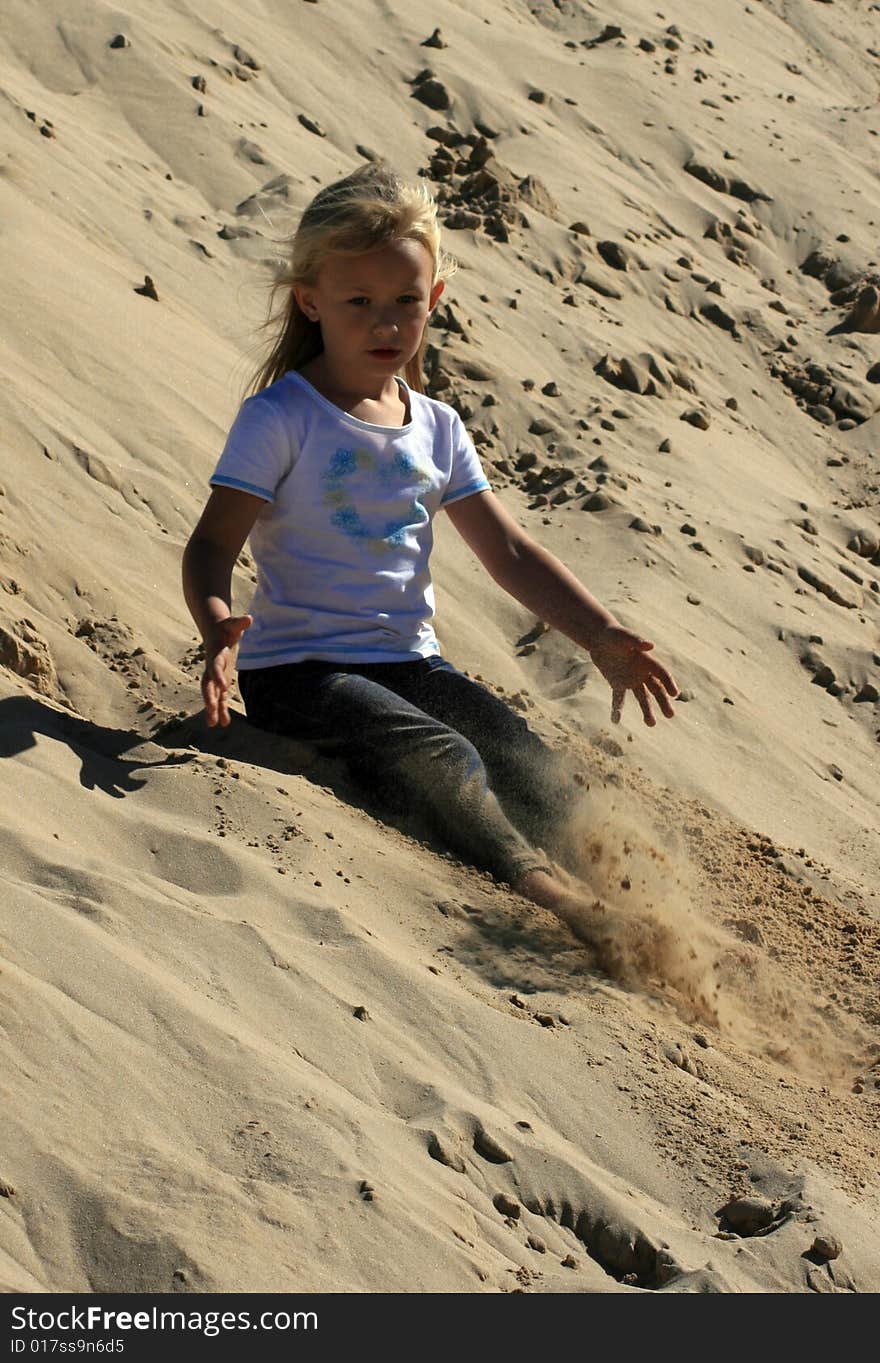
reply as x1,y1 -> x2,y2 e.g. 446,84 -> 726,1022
0,0 -> 880,1292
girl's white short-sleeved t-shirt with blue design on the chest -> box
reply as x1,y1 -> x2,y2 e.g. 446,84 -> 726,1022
211,371 -> 489,669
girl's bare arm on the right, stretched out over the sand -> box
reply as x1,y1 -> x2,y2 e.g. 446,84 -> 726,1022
447,492 -> 678,724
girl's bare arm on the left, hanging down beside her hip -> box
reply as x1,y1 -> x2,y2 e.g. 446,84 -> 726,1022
183,488 -> 266,726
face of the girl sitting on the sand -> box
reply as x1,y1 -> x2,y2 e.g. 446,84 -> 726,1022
294,240 -> 443,386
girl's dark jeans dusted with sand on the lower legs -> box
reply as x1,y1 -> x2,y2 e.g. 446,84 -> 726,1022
238,657 -> 575,883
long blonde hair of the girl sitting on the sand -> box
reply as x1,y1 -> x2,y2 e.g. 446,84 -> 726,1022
248,161 -> 455,393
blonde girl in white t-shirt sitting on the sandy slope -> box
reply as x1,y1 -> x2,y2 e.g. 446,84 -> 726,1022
184,162 -> 677,947
